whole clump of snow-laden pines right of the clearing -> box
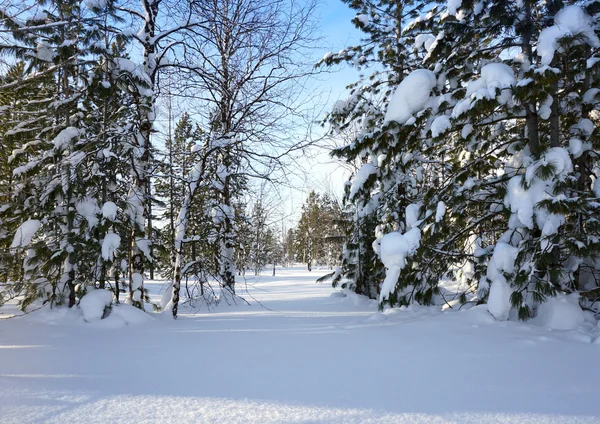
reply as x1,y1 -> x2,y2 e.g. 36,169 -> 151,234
320,0 -> 600,320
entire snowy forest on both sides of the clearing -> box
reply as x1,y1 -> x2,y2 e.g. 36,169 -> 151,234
0,0 -> 600,327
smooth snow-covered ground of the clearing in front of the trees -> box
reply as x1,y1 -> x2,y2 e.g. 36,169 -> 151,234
0,269 -> 600,423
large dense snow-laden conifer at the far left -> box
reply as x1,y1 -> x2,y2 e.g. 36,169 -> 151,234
2,2 -> 140,308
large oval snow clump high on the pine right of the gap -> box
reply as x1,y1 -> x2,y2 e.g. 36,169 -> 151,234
384,69 -> 437,124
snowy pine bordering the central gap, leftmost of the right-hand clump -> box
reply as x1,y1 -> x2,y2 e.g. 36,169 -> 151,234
321,0 -> 435,298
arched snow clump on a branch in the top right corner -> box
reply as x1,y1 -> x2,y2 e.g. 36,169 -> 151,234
537,5 -> 600,65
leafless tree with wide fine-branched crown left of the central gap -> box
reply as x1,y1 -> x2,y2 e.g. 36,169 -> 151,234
164,0 -> 322,316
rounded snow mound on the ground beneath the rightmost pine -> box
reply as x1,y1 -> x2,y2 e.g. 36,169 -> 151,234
535,293 -> 585,330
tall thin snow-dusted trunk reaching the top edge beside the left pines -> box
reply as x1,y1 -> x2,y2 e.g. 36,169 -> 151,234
119,0 -> 209,307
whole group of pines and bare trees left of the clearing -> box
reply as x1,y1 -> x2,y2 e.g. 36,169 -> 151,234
0,0 -> 314,316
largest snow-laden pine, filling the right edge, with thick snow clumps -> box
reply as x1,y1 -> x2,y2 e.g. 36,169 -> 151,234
384,2 -> 599,319
